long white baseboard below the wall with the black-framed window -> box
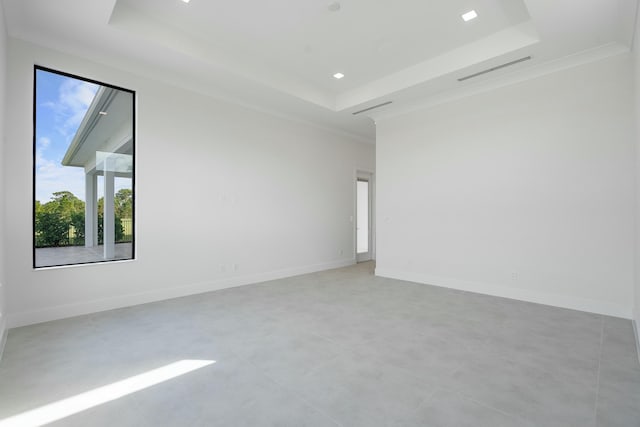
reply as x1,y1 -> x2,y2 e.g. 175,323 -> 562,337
6,259 -> 355,328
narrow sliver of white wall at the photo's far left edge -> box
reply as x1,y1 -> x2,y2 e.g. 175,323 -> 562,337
0,3 -> 7,358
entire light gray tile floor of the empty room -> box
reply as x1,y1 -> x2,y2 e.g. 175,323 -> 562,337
0,263 -> 640,427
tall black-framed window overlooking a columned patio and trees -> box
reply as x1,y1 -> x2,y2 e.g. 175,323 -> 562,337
33,66 -> 135,268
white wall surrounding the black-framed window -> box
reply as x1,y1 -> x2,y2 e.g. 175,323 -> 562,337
5,40 -> 375,326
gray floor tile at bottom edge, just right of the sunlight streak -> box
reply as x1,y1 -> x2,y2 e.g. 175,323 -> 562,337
48,359 -> 336,426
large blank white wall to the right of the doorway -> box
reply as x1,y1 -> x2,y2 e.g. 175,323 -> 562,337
376,55 -> 635,318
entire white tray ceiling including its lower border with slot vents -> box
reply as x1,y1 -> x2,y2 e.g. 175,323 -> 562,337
4,0 -> 637,141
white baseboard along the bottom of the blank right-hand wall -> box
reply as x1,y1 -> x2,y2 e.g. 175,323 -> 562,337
375,268 -> 632,319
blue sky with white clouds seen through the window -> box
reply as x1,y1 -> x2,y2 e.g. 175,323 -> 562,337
36,70 -> 99,203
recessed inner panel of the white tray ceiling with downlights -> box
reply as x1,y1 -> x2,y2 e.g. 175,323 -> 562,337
111,0 -> 529,97
